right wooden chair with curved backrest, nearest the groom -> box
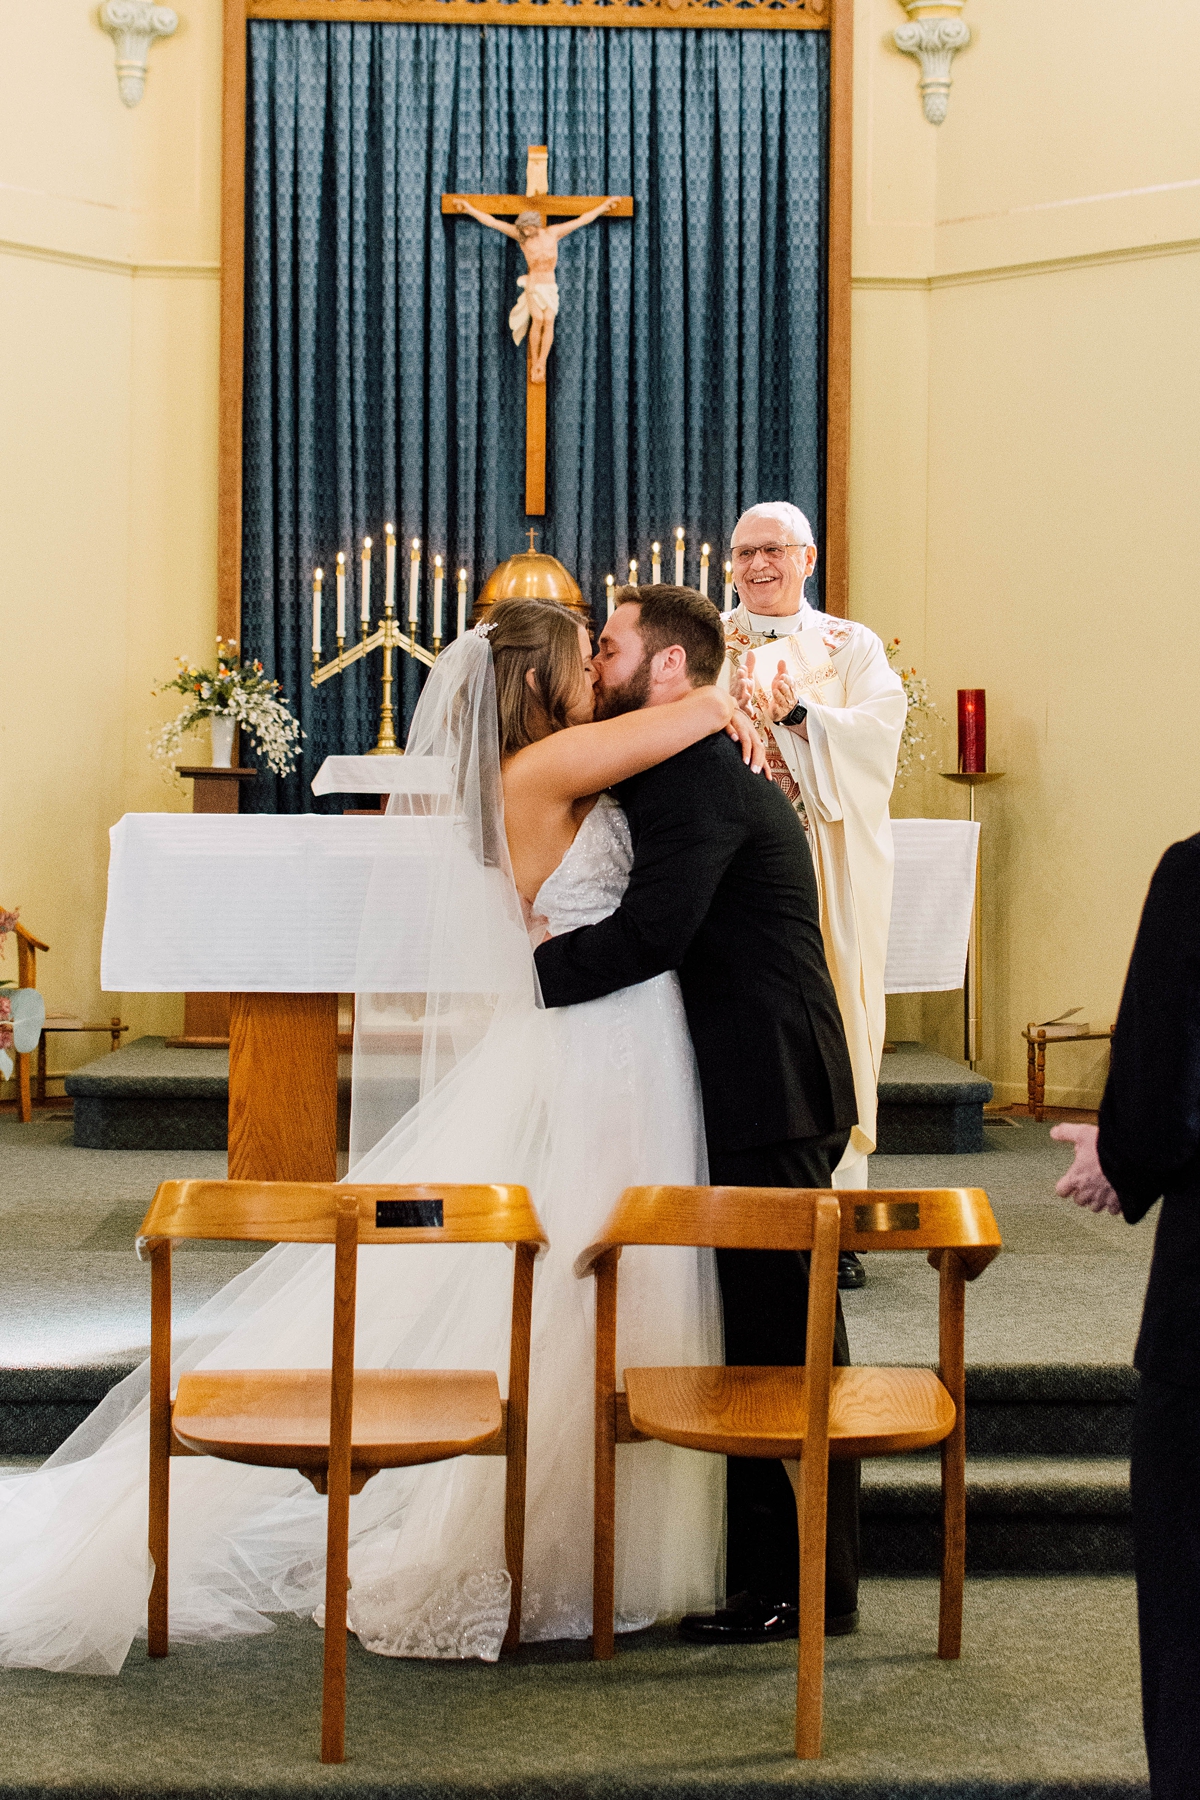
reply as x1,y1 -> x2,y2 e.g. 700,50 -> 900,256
576,1188 -> 1000,1757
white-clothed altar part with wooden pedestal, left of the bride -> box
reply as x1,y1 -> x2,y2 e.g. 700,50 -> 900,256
101,813 -> 482,1181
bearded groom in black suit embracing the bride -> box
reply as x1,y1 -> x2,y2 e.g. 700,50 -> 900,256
536,587 -> 858,1643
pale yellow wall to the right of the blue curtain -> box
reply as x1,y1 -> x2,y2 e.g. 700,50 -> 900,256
851,0 -> 1200,1105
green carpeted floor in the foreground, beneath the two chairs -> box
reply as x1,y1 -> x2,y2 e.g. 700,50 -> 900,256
0,1577 -> 1148,1800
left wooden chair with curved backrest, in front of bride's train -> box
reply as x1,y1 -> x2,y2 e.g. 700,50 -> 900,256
139,1181 -> 547,1762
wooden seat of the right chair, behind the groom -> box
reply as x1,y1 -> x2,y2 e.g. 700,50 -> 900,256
624,1368 -> 955,1460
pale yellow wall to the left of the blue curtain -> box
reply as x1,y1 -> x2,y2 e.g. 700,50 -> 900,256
0,0 -> 221,1067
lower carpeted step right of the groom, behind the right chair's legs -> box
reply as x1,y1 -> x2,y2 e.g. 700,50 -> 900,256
862,1453 -> 1133,1575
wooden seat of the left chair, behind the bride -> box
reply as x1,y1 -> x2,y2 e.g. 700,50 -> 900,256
171,1368 -> 504,1469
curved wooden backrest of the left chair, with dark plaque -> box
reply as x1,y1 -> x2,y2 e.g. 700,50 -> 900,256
139,1181 -> 547,1247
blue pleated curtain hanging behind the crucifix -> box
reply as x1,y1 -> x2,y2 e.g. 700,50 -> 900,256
243,22 -> 828,812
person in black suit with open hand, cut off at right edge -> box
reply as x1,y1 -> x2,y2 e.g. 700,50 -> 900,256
1051,835 -> 1200,1800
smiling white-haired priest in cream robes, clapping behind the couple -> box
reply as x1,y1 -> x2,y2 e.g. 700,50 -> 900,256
721,500 -> 909,1287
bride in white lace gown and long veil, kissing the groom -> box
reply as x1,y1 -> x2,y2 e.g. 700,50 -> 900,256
0,601 -> 763,1674
